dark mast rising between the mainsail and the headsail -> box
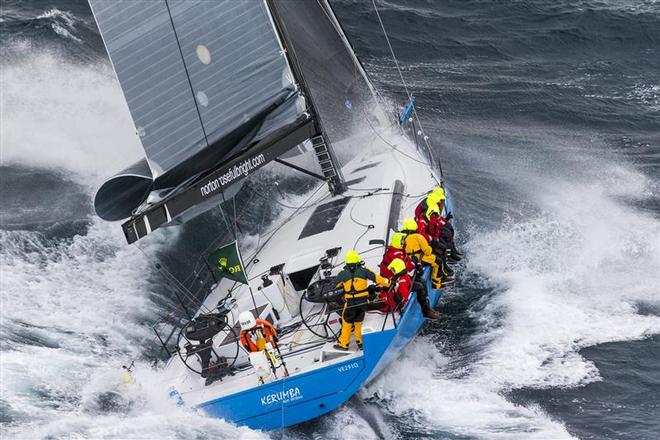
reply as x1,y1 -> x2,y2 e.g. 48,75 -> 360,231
265,0 -> 346,195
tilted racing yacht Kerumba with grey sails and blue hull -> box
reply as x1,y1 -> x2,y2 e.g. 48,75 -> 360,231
89,0 -> 451,430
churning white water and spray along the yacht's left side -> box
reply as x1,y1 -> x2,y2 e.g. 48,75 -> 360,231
0,49 -> 255,439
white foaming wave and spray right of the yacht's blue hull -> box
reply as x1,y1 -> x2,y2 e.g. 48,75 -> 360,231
369,136 -> 660,439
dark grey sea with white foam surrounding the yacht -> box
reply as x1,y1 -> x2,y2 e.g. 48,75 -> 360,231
0,0 -> 660,439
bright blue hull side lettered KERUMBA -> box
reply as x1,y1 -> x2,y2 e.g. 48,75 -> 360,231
197,193 -> 449,430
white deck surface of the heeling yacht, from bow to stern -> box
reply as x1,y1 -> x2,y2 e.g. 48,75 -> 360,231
163,124 -> 439,406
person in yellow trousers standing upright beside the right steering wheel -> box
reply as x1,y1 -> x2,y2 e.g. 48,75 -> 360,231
334,250 -> 390,351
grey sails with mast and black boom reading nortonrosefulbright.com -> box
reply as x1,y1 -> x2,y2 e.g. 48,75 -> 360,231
89,0 -> 382,243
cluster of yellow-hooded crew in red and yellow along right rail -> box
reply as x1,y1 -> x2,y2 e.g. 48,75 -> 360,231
334,187 -> 463,351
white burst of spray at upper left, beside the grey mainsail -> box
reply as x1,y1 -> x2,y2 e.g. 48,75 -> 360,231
0,52 -> 142,185
